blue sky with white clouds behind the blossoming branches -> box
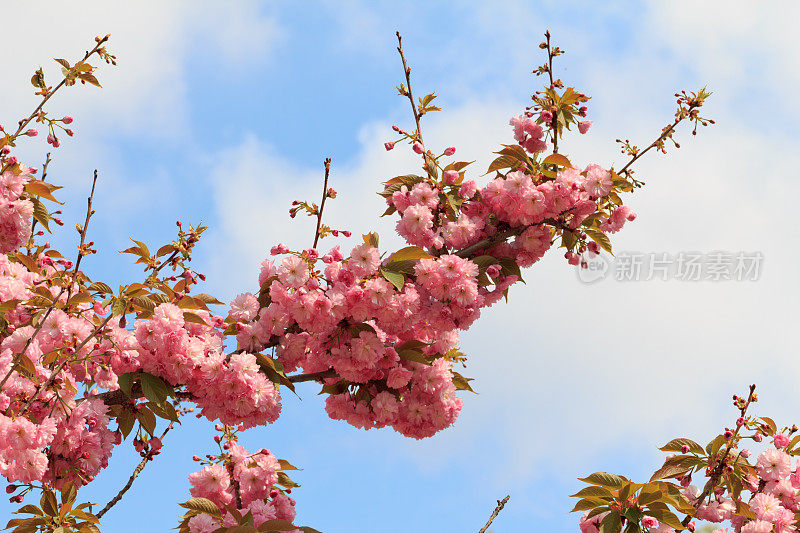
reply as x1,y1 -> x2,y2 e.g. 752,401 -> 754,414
0,1 -> 800,533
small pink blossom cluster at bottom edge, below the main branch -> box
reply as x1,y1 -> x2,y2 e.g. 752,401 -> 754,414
188,442 -> 296,533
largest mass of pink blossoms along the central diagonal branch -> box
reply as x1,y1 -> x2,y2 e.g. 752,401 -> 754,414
223,110 -> 633,438
